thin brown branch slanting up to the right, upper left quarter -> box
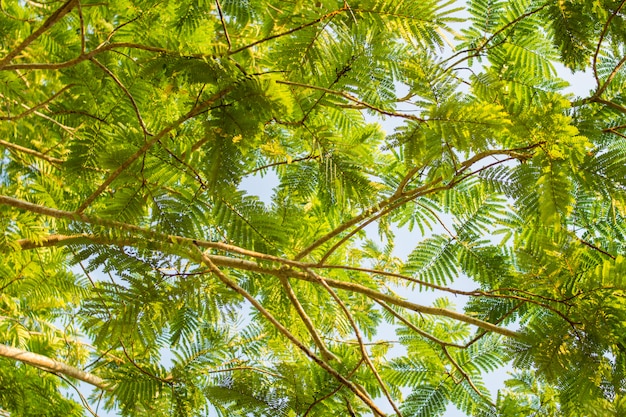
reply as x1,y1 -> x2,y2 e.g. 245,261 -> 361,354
76,86 -> 233,214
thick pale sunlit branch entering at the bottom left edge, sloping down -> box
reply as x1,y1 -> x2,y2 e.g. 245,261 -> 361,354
0,343 -> 112,391
